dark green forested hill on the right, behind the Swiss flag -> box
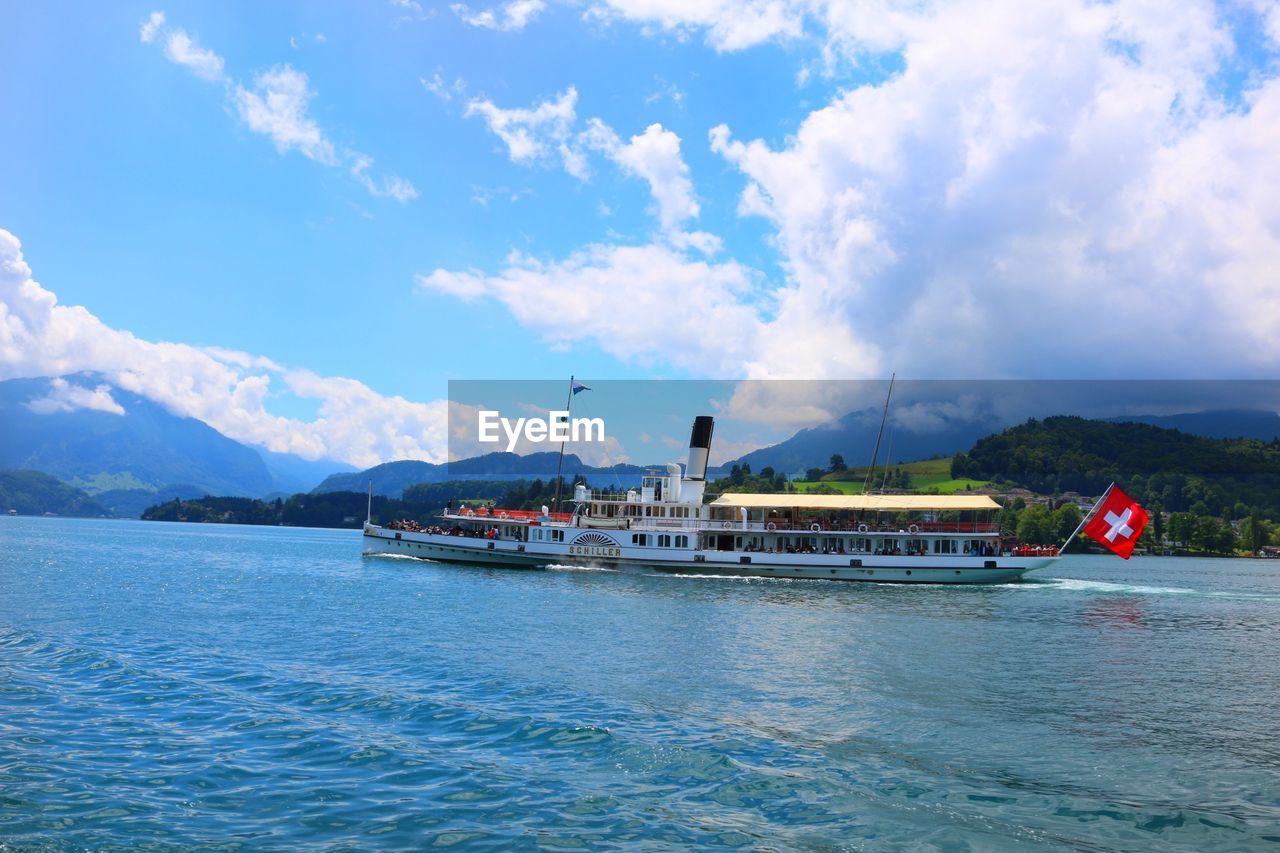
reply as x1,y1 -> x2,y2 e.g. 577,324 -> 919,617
951,416 -> 1280,519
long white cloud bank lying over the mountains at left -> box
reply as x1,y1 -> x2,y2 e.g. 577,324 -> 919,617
0,229 -> 447,466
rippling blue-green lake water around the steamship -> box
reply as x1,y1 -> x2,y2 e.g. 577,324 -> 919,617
0,519 -> 1280,850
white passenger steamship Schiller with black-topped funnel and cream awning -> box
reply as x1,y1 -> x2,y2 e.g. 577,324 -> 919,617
364,415 -> 1060,584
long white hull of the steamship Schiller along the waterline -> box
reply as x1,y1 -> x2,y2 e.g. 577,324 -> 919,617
364,525 -> 1059,584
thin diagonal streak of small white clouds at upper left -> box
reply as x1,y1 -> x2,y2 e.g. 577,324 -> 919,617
138,12 -> 417,204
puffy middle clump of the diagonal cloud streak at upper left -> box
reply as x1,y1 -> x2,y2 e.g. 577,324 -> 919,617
236,65 -> 338,165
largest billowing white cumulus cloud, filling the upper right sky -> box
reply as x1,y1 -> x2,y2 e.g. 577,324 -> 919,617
710,3 -> 1280,377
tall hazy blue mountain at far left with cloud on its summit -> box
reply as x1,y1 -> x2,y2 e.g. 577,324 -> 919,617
0,374 -> 352,516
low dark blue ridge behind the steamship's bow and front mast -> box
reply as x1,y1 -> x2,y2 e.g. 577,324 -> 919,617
312,452 -> 658,497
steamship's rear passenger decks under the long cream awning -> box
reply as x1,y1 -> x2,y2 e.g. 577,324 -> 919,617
701,493 -> 1001,557
